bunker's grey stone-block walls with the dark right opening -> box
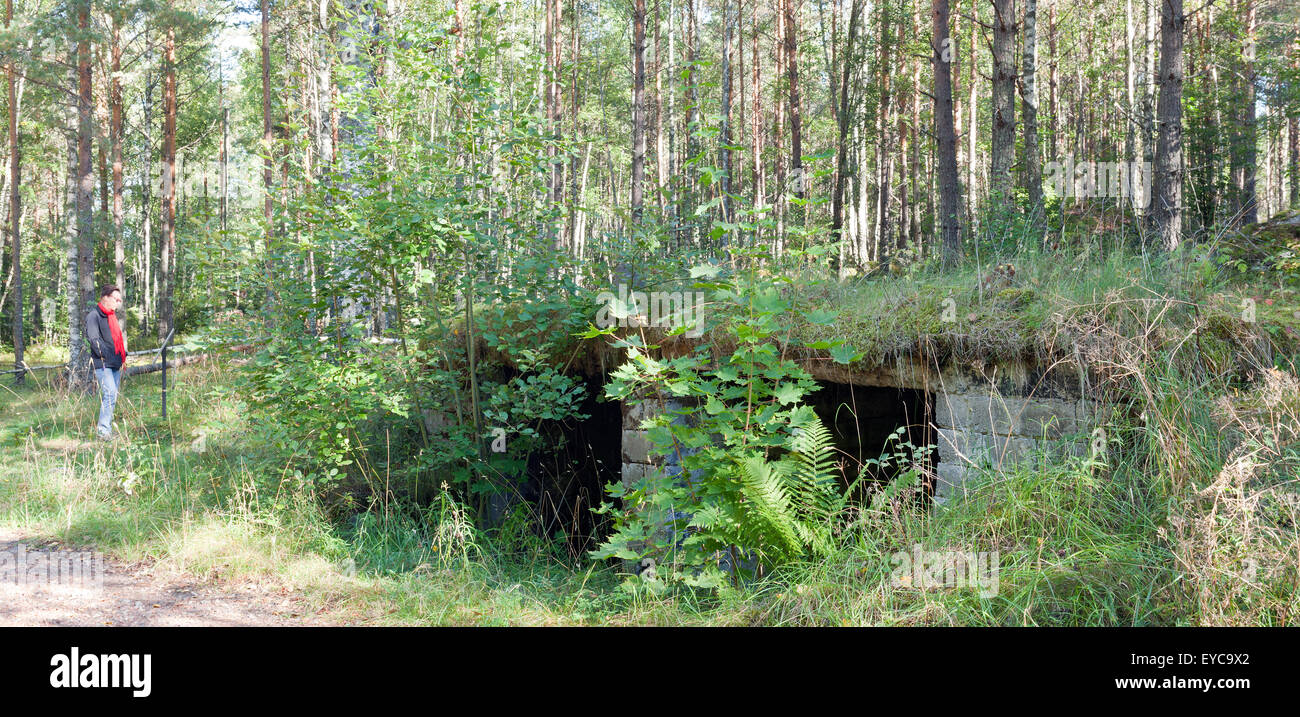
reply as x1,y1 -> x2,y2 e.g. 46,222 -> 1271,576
621,360 -> 1095,504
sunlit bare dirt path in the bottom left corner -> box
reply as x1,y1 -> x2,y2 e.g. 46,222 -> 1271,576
0,529 -> 322,627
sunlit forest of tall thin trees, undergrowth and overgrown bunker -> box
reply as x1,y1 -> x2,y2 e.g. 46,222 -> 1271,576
0,0 -> 1300,626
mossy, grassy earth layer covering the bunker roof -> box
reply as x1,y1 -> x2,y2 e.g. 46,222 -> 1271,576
475,251 -> 1279,392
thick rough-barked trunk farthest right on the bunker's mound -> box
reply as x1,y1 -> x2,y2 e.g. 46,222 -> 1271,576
1149,0 -> 1187,249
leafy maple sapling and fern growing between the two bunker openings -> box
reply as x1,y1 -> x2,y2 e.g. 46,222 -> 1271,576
593,255 -> 844,587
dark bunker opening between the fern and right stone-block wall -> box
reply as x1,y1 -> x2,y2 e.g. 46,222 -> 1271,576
809,381 -> 939,501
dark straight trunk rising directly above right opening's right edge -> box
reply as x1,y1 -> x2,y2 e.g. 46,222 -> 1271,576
931,0 -> 974,266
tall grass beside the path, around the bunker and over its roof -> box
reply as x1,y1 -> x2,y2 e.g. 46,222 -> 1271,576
0,239 -> 1300,625
